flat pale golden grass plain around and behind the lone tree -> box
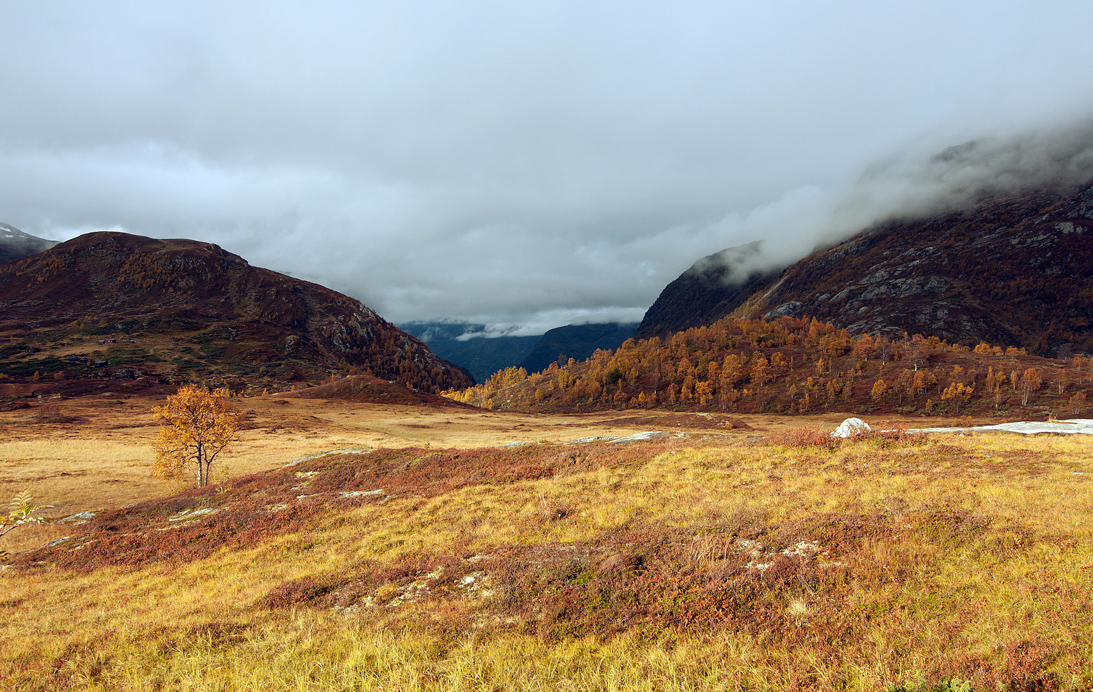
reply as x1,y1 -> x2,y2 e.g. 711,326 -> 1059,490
0,396 -> 782,520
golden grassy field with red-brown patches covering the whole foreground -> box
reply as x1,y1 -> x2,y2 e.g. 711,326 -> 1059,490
0,399 -> 1093,691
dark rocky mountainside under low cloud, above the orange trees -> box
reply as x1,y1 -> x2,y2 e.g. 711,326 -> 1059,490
639,183 -> 1093,355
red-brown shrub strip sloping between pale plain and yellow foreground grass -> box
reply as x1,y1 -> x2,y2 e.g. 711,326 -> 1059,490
8,443 -> 665,571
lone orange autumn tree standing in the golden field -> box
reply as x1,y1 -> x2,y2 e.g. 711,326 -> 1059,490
152,385 -> 239,488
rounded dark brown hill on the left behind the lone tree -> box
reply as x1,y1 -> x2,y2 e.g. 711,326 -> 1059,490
0,233 -> 471,392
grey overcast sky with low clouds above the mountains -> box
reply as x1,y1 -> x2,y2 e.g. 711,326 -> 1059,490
0,0 -> 1093,332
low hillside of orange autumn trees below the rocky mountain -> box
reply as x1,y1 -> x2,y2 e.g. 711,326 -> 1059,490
444,317 -> 1093,415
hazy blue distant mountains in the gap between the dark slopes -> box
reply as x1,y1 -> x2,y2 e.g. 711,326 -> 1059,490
399,321 -> 540,382
